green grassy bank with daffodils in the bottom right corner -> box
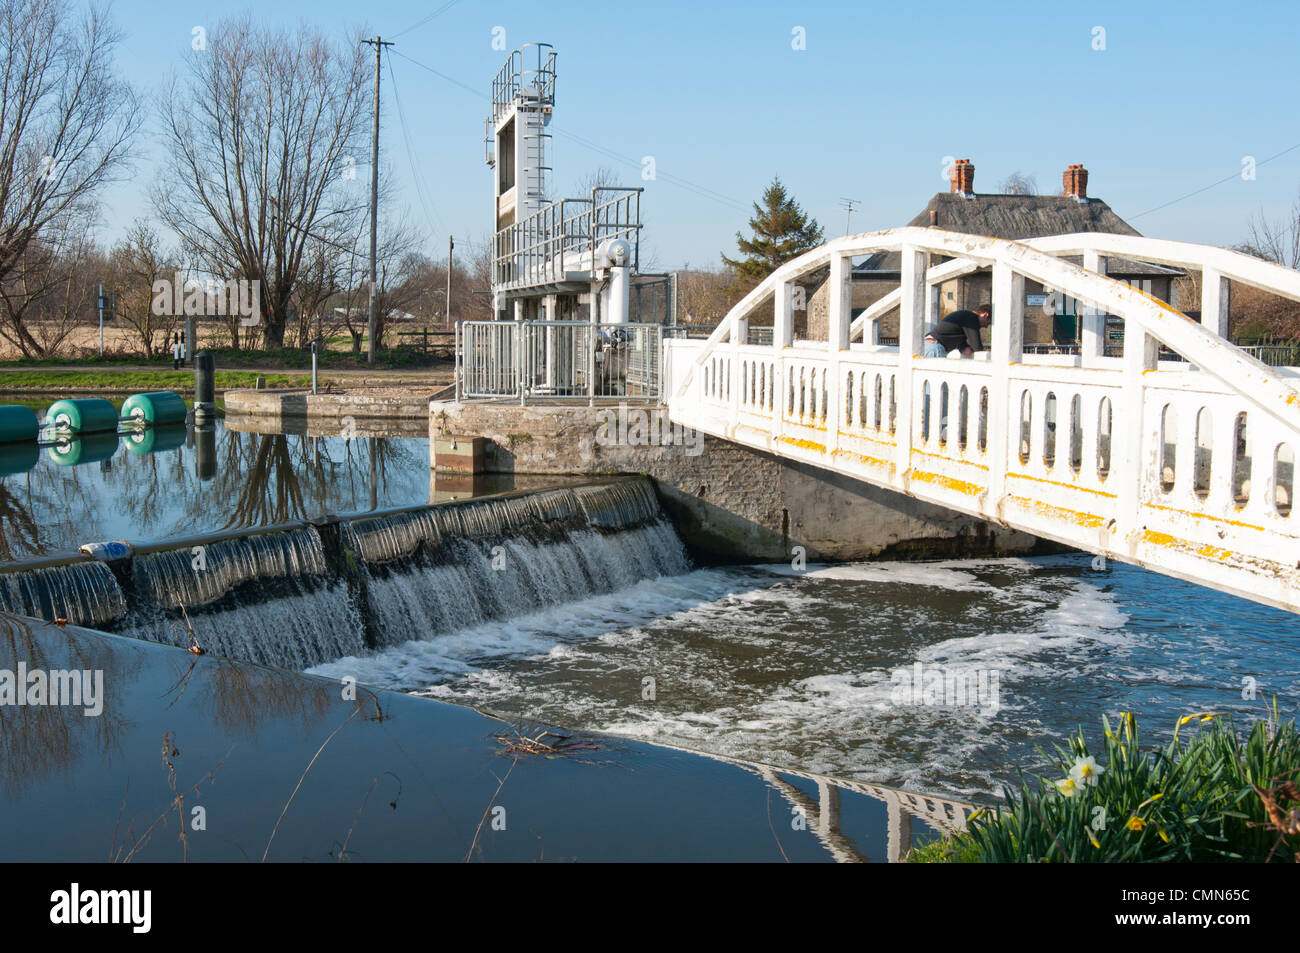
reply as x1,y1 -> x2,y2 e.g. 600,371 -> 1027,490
906,709 -> 1300,863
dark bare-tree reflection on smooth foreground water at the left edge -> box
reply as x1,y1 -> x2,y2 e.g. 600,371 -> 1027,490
0,614 -> 134,800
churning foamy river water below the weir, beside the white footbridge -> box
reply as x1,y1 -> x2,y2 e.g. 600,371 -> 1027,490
312,555 -> 1300,800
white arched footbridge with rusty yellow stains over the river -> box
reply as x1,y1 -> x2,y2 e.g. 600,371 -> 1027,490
664,228 -> 1300,611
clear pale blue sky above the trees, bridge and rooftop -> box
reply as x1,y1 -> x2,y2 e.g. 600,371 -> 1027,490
98,0 -> 1300,269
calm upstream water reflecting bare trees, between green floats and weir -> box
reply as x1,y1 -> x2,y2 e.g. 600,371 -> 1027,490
0,426 -> 428,560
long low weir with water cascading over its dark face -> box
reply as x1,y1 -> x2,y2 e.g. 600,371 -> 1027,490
0,477 -> 690,670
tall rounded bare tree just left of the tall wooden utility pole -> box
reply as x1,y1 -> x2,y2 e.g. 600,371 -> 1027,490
153,17 -> 369,347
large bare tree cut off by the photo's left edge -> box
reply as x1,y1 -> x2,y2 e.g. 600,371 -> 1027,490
0,0 -> 139,355
